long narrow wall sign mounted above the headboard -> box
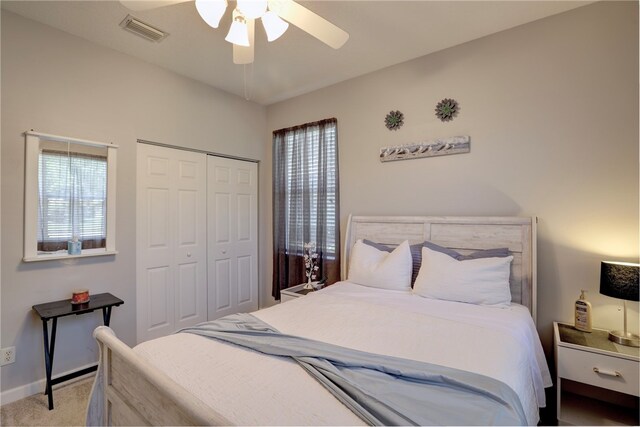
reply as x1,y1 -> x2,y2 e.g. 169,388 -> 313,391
380,136 -> 471,162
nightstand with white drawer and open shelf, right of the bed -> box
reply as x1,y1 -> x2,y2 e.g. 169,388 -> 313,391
553,322 -> 640,425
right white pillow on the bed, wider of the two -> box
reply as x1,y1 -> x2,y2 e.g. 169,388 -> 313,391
413,247 -> 513,307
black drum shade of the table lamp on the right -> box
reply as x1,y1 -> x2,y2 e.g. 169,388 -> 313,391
600,261 -> 640,301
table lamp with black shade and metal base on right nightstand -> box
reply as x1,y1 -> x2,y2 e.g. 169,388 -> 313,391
600,261 -> 640,347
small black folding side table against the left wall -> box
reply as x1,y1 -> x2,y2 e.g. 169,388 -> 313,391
31,293 -> 124,410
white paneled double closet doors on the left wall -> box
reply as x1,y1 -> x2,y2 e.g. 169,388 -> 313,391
136,143 -> 258,342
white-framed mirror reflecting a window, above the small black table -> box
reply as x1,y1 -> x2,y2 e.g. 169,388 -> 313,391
24,132 -> 117,261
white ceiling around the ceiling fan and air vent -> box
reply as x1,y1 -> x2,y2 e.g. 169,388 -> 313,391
1,0 -> 591,105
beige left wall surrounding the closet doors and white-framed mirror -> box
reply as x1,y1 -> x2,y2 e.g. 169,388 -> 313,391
1,11 -> 270,391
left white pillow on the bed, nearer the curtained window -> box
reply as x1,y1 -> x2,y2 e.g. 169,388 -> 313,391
349,240 -> 413,290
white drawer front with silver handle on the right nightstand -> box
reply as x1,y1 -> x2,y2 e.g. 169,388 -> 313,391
558,346 -> 640,396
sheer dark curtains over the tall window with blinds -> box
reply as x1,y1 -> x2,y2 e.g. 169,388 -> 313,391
272,118 -> 340,300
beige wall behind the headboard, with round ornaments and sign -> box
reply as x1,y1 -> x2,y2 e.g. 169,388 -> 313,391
267,2 -> 638,350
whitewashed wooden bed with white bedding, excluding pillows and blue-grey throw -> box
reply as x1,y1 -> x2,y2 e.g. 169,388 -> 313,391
87,216 -> 551,425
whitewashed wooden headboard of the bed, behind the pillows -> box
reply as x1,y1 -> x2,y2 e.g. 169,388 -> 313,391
342,216 -> 537,322
